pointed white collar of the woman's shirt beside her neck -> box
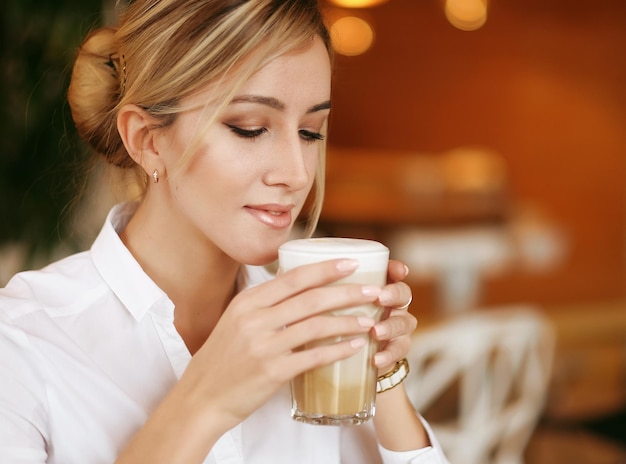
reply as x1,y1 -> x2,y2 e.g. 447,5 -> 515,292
91,203 -> 169,320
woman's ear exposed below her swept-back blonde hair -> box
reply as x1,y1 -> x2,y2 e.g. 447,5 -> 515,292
117,105 -> 164,176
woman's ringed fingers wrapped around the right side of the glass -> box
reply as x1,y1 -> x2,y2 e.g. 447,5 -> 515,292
373,260 -> 417,373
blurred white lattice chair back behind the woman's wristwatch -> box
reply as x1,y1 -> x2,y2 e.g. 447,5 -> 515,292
406,306 -> 554,464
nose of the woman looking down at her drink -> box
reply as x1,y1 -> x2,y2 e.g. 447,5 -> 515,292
263,132 -> 312,191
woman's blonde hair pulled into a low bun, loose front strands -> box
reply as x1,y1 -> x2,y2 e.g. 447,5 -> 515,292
68,0 -> 331,233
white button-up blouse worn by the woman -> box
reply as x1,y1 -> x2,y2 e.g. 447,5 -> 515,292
0,204 -> 447,464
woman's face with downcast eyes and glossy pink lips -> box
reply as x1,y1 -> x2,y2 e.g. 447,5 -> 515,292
152,39 -> 331,265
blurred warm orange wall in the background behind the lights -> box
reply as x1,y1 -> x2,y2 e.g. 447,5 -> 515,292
322,0 -> 626,312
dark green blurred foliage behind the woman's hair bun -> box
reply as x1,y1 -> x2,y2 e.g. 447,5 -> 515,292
0,0 -> 102,260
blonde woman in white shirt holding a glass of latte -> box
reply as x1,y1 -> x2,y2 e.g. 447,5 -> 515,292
0,0 -> 445,463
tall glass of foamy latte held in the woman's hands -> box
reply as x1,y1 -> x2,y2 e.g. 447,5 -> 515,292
279,238 -> 389,425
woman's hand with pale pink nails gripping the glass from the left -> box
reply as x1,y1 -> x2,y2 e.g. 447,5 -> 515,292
180,260 -> 380,429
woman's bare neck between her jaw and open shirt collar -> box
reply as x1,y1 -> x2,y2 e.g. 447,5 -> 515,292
120,198 -> 241,354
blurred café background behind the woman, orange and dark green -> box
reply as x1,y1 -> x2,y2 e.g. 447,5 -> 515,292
0,0 -> 626,464
